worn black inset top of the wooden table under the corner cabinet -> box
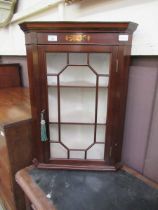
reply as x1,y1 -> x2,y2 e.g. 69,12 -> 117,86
30,169 -> 158,210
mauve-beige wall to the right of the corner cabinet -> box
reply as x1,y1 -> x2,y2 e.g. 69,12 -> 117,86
122,57 -> 158,182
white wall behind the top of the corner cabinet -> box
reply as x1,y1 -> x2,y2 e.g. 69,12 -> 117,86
0,0 -> 158,55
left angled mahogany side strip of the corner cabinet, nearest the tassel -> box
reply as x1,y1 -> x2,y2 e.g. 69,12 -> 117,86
26,45 -> 44,162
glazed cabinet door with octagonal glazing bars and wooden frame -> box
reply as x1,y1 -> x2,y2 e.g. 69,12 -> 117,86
35,46 -> 117,171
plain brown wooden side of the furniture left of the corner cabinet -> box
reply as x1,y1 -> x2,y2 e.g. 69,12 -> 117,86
6,120 -> 33,210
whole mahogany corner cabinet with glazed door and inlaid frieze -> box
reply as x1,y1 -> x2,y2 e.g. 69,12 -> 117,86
20,22 -> 137,170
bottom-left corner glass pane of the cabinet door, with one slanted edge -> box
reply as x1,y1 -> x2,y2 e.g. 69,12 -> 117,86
50,143 -> 67,158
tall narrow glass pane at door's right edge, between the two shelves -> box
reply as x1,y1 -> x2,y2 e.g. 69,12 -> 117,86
98,88 -> 108,123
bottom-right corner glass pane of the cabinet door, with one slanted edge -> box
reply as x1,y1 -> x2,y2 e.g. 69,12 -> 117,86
87,144 -> 104,160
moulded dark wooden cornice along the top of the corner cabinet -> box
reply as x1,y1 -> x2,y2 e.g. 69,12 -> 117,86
20,21 -> 138,33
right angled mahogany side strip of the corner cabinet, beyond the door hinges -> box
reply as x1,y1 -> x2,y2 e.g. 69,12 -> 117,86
113,45 -> 131,163
